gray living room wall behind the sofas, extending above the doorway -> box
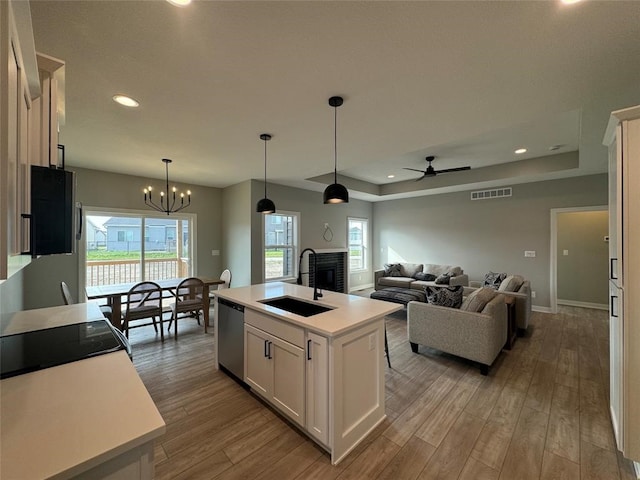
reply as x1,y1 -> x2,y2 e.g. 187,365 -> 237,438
373,174 -> 607,307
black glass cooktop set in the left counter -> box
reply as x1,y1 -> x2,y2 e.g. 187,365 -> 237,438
0,320 -> 131,378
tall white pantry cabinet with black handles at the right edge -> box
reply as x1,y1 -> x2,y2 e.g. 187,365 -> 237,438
604,106 -> 640,466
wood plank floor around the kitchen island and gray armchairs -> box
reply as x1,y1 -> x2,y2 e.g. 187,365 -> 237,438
131,308 -> 635,480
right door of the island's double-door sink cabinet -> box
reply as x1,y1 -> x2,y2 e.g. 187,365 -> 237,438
269,337 -> 305,427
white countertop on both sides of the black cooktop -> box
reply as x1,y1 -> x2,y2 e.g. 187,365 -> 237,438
0,304 -> 165,479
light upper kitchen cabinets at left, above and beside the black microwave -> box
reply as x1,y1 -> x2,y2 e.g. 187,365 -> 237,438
0,0 -> 64,281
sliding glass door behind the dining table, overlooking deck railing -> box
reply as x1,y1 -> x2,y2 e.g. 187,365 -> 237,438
85,211 -> 194,286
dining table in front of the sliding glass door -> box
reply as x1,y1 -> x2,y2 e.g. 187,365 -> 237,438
85,276 -> 225,333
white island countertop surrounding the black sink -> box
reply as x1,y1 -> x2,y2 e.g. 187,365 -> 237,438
215,282 -> 403,337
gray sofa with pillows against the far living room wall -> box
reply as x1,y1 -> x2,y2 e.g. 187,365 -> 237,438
374,262 -> 469,290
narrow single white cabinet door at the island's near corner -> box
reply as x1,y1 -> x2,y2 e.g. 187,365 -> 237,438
306,332 -> 331,447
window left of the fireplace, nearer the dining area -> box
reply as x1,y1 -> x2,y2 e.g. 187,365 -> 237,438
263,212 -> 299,282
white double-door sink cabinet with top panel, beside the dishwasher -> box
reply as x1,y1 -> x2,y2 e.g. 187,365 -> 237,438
244,310 -> 305,427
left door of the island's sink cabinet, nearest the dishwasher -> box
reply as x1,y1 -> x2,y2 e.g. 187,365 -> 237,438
244,324 -> 273,399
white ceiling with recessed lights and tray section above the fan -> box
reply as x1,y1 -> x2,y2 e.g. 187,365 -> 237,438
30,0 -> 640,201
